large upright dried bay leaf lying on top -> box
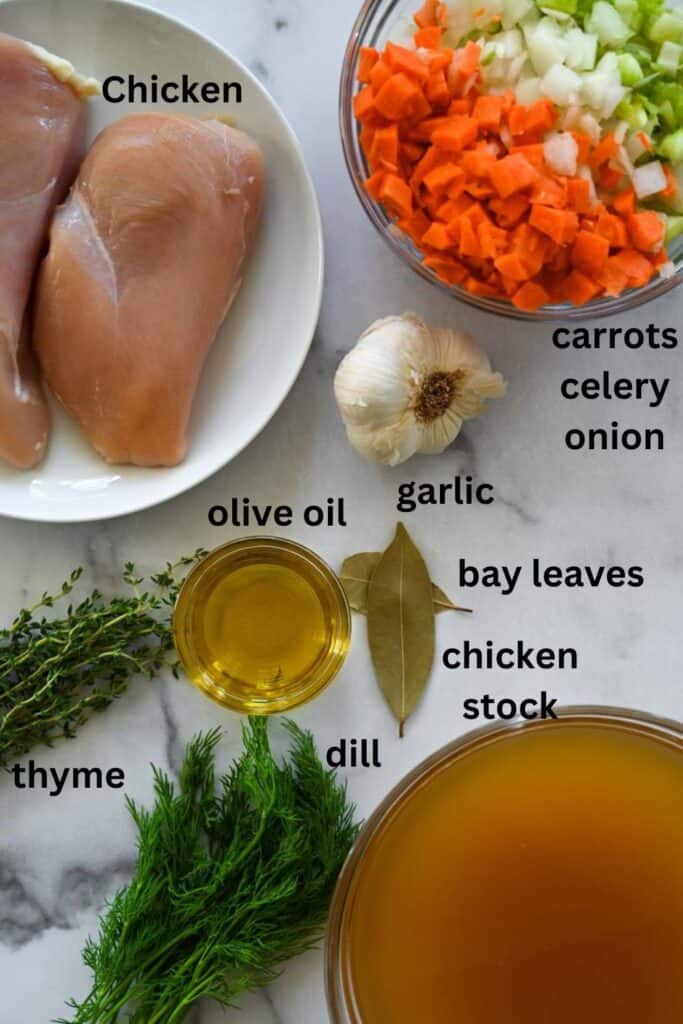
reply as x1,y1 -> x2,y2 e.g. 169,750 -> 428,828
368,523 -> 435,736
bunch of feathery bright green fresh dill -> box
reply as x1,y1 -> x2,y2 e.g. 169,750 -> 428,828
56,719 -> 358,1024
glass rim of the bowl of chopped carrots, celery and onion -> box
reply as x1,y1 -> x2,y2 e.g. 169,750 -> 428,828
339,0 -> 683,324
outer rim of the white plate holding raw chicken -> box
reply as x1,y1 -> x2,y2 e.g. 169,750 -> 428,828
0,0 -> 326,525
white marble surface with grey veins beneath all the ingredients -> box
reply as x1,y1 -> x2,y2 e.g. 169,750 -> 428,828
0,0 -> 683,1024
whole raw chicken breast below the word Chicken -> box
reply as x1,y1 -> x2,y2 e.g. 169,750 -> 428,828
34,114 -> 264,466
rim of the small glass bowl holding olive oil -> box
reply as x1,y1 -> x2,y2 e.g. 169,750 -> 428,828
171,535 -> 352,715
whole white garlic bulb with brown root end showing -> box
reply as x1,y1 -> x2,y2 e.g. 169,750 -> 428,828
335,313 -> 506,466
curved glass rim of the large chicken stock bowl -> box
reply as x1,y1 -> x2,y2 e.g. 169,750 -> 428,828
324,705 -> 683,1024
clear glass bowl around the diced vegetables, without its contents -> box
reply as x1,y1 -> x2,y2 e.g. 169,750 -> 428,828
339,0 -> 683,323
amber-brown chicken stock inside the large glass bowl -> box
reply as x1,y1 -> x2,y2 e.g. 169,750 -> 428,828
343,720 -> 683,1024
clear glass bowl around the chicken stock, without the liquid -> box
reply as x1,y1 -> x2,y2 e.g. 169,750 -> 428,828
325,707 -> 683,1024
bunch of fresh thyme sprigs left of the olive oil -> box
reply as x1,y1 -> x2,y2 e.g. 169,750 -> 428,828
0,551 -> 204,768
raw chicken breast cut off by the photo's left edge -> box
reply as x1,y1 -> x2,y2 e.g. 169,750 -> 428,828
0,34 -> 85,469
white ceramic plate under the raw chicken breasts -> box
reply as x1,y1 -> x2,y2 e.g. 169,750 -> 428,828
0,0 -> 324,522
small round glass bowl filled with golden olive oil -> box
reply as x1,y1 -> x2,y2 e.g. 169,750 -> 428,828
173,538 -> 351,715
